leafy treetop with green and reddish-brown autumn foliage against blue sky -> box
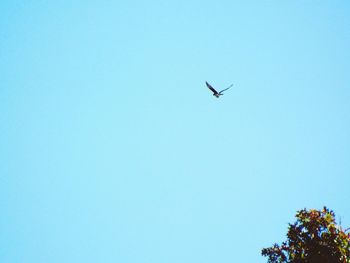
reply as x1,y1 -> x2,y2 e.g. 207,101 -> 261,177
261,207 -> 350,263
